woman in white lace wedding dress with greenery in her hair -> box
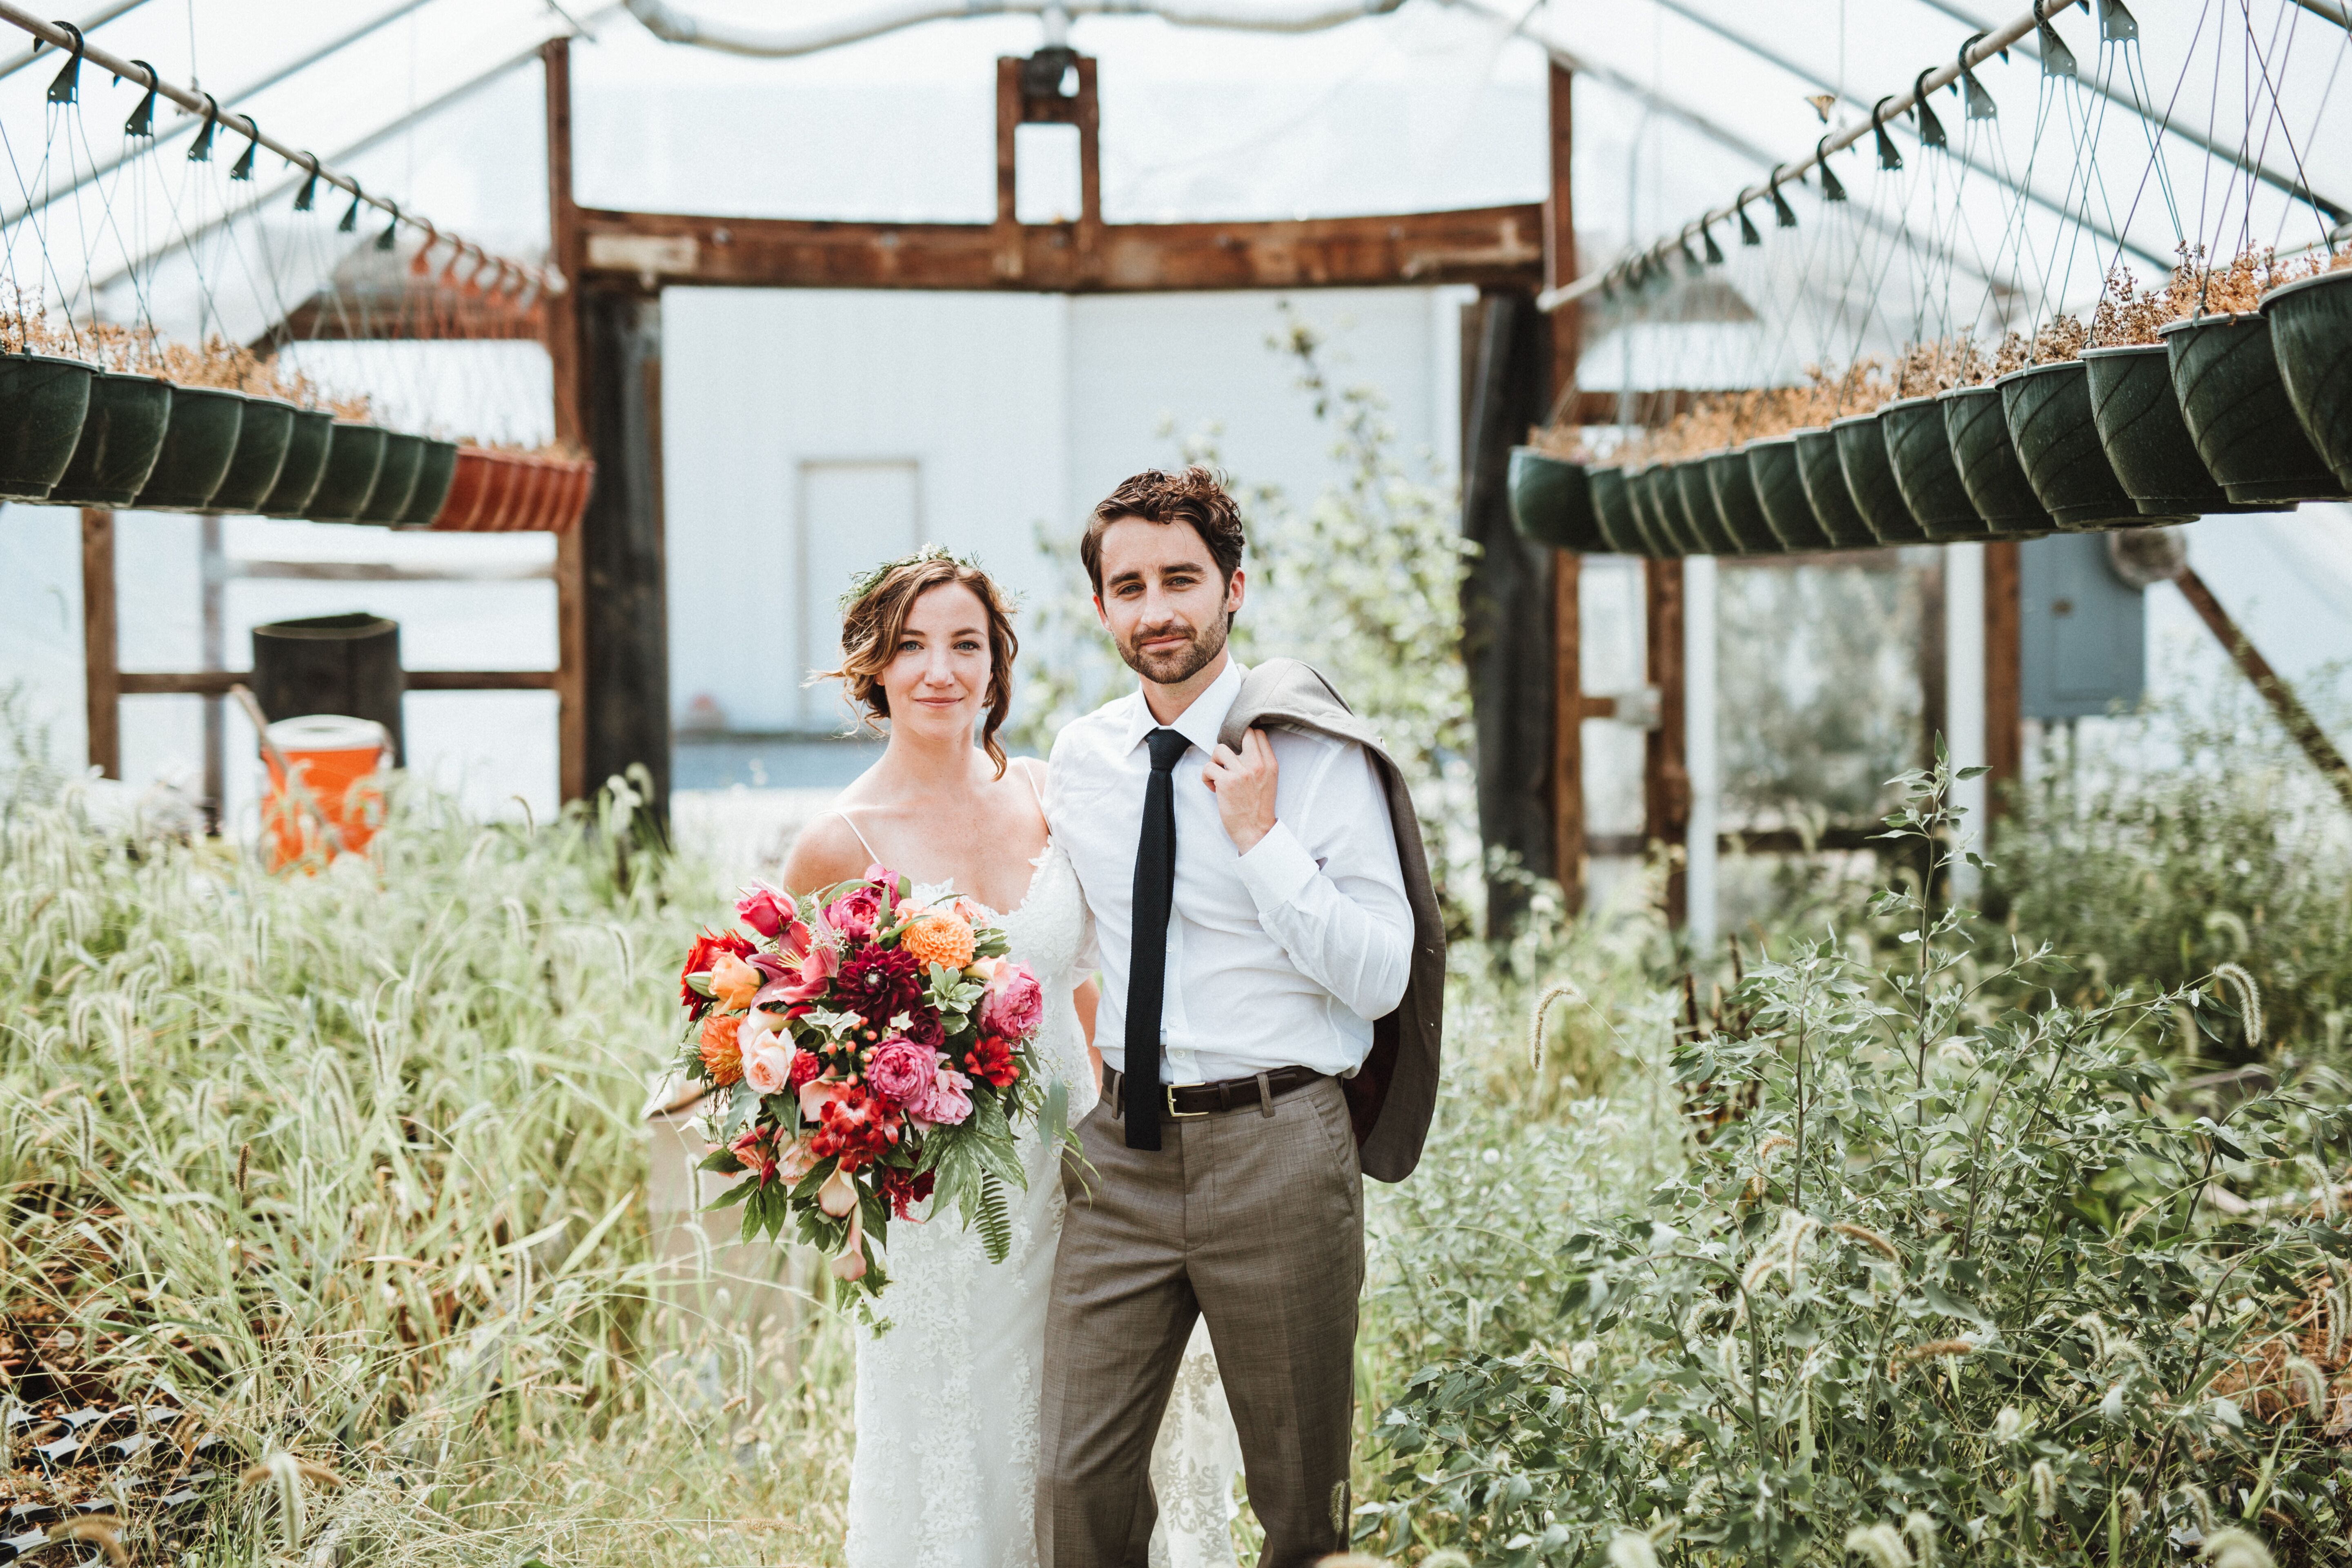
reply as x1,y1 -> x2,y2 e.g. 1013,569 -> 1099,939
783,548 -> 1240,1568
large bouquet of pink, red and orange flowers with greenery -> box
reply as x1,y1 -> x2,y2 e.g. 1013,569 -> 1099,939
680,865 -> 1065,1295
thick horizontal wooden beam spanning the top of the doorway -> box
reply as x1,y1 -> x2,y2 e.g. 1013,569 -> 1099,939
579,204 -> 1543,294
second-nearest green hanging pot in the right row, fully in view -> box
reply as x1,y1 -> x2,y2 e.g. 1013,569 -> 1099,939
2157,310 -> 2352,503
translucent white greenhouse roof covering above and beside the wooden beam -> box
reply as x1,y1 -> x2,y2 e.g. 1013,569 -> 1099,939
0,0 -> 2352,385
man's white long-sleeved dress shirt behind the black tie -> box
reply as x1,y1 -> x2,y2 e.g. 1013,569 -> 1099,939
1047,663 -> 1414,1084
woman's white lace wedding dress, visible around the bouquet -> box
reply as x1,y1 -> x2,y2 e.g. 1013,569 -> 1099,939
847,846 -> 1242,1568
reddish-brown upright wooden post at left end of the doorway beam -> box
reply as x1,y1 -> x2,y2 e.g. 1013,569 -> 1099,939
541,38 -> 590,799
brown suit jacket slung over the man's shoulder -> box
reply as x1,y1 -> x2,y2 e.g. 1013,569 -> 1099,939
1216,658 -> 1446,1183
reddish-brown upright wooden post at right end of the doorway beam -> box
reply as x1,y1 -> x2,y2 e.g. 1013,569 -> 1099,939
1543,61 -> 1585,915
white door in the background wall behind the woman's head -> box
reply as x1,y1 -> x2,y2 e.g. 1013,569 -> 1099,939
800,459 -> 922,731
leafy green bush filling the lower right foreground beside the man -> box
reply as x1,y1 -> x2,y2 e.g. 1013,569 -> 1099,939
1357,764 -> 2352,1566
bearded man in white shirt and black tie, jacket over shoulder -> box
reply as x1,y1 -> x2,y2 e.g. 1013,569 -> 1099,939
1037,468 -> 1444,1568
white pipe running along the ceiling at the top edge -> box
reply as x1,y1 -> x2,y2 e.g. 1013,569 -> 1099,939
626,0 -> 1404,59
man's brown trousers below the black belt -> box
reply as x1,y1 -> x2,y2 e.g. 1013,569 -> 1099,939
1037,1079 -> 1364,1568
